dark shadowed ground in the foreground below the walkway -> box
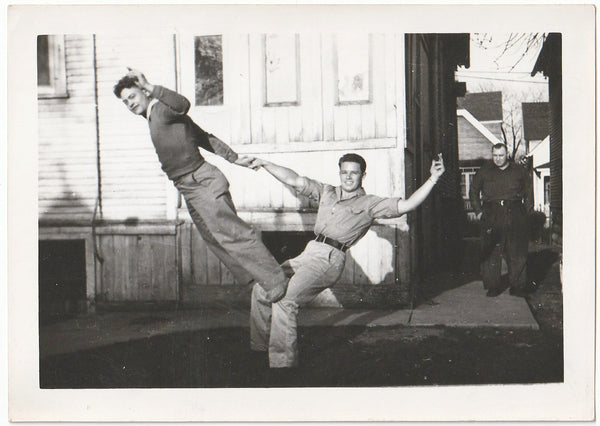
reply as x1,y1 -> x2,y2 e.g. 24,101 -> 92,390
40,243 -> 563,388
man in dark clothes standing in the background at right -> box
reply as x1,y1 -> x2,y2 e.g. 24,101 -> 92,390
469,144 -> 533,297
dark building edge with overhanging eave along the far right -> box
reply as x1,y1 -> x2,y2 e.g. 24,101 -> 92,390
531,33 -> 563,246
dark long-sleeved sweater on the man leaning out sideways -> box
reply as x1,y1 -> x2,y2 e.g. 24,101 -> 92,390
148,86 -> 238,180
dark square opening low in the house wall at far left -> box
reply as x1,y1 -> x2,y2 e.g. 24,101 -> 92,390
38,240 -> 86,324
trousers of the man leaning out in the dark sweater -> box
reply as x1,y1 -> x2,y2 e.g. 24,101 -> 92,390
175,162 -> 287,291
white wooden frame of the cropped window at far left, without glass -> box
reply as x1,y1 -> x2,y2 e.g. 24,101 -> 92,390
38,34 -> 69,99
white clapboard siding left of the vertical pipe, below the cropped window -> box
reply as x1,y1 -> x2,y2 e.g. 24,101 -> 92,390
38,35 -> 98,220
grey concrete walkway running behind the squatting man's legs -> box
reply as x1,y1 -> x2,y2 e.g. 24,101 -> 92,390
40,281 -> 539,357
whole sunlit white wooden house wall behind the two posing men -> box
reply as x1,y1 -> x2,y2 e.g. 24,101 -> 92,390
39,34 -> 404,220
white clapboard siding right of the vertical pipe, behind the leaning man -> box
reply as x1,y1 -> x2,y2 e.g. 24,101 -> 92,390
96,34 -> 175,220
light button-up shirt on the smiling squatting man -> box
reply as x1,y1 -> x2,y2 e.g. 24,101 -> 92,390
298,177 -> 402,245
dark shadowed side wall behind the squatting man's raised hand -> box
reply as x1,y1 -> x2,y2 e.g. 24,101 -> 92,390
405,33 -> 470,301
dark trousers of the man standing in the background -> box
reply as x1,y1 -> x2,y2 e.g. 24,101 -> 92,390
481,201 -> 528,289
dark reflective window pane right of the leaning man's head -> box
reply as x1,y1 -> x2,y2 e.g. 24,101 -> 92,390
194,35 -> 223,105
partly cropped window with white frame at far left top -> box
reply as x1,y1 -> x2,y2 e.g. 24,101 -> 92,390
37,35 -> 67,98
